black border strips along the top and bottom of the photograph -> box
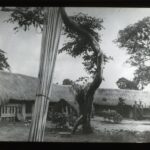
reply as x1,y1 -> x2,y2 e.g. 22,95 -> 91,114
0,0 -> 150,150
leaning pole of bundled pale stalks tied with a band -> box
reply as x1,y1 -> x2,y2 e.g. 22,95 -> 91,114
28,7 -> 62,142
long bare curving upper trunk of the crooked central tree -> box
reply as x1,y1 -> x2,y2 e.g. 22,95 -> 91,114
60,7 -> 104,95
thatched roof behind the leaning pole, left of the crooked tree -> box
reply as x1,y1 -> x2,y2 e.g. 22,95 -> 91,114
0,71 -> 75,104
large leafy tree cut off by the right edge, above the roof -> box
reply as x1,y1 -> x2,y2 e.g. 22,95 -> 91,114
115,17 -> 150,89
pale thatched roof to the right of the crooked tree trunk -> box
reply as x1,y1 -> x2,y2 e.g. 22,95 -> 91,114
94,89 -> 150,106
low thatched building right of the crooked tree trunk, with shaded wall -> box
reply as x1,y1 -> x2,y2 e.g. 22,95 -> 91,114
94,89 -> 150,118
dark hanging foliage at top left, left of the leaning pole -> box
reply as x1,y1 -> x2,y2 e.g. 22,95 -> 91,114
4,7 -> 44,31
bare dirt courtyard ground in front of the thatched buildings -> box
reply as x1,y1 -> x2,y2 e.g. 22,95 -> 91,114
0,117 -> 150,143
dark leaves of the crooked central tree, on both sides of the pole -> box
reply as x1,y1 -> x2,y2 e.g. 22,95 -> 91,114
3,7 -> 112,75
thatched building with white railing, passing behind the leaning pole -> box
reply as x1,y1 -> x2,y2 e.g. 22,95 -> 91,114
0,71 -> 78,120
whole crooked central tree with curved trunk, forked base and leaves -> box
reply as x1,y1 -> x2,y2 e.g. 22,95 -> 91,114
2,7 -> 109,133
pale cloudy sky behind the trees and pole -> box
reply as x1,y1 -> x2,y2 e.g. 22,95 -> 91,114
0,7 -> 150,91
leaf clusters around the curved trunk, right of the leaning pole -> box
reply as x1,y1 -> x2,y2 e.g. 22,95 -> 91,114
59,13 -> 111,75
